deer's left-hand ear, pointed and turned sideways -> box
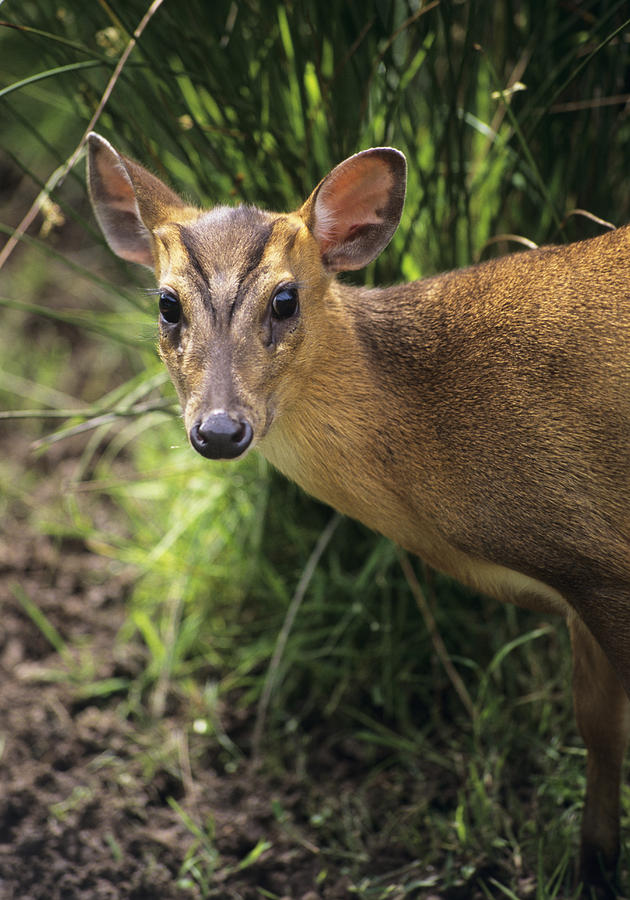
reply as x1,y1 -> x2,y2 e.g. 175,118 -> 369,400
88,132 -> 185,269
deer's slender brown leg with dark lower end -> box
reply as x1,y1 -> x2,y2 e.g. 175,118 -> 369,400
568,615 -> 630,897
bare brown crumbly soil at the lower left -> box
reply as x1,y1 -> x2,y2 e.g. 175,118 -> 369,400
0,458 -> 358,900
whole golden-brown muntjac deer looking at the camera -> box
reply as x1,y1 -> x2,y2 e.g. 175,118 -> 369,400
89,134 -> 630,897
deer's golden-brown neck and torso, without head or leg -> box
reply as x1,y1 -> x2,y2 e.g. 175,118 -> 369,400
270,236 -> 630,632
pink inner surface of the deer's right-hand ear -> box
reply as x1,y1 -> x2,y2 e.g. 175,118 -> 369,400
314,158 -> 392,253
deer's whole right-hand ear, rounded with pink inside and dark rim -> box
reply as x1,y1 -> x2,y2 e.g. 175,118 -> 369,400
300,147 -> 407,272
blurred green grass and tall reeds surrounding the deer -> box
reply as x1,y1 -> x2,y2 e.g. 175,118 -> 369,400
0,0 -> 630,897
